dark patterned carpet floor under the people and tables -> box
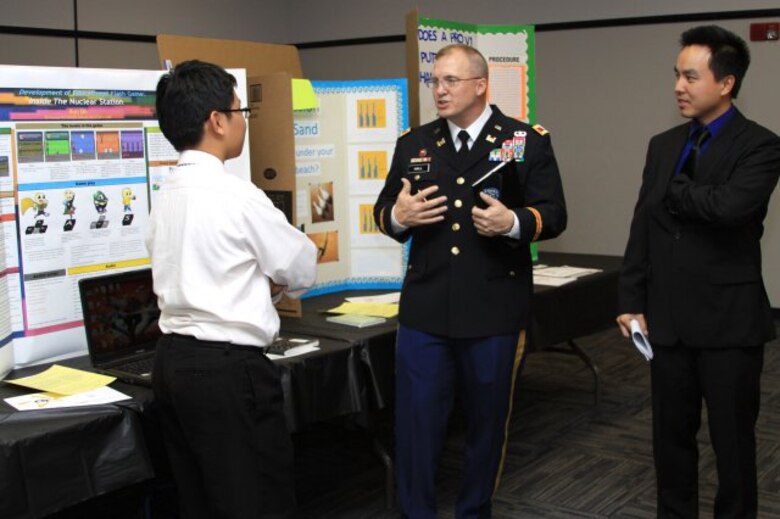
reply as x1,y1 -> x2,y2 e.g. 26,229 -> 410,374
296,330 -> 780,519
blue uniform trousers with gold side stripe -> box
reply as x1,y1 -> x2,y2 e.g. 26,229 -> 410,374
396,326 -> 525,519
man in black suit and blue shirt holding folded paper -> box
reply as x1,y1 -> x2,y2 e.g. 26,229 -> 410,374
617,26 -> 780,519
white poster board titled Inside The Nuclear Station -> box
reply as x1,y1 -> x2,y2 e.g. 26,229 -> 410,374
0,66 -> 249,365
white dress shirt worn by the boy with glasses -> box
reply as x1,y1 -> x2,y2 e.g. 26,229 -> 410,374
146,150 -> 317,346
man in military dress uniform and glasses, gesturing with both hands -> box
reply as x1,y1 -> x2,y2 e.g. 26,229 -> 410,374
374,45 -> 566,518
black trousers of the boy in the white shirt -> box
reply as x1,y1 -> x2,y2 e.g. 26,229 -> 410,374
152,335 -> 295,519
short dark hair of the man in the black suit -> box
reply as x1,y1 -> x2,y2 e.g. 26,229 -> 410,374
680,25 -> 750,99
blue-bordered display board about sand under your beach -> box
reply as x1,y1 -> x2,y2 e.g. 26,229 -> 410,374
294,79 -> 408,297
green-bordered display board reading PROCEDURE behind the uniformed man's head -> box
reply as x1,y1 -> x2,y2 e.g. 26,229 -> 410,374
417,18 -> 536,124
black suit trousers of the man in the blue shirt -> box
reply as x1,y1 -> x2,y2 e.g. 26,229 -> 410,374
651,345 -> 764,519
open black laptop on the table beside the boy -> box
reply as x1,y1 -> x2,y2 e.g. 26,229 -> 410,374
79,269 -> 162,386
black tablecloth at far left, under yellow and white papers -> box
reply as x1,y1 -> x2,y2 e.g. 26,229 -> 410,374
0,357 -> 154,519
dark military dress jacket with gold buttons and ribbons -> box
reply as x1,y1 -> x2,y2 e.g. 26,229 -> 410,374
374,106 -> 566,338
